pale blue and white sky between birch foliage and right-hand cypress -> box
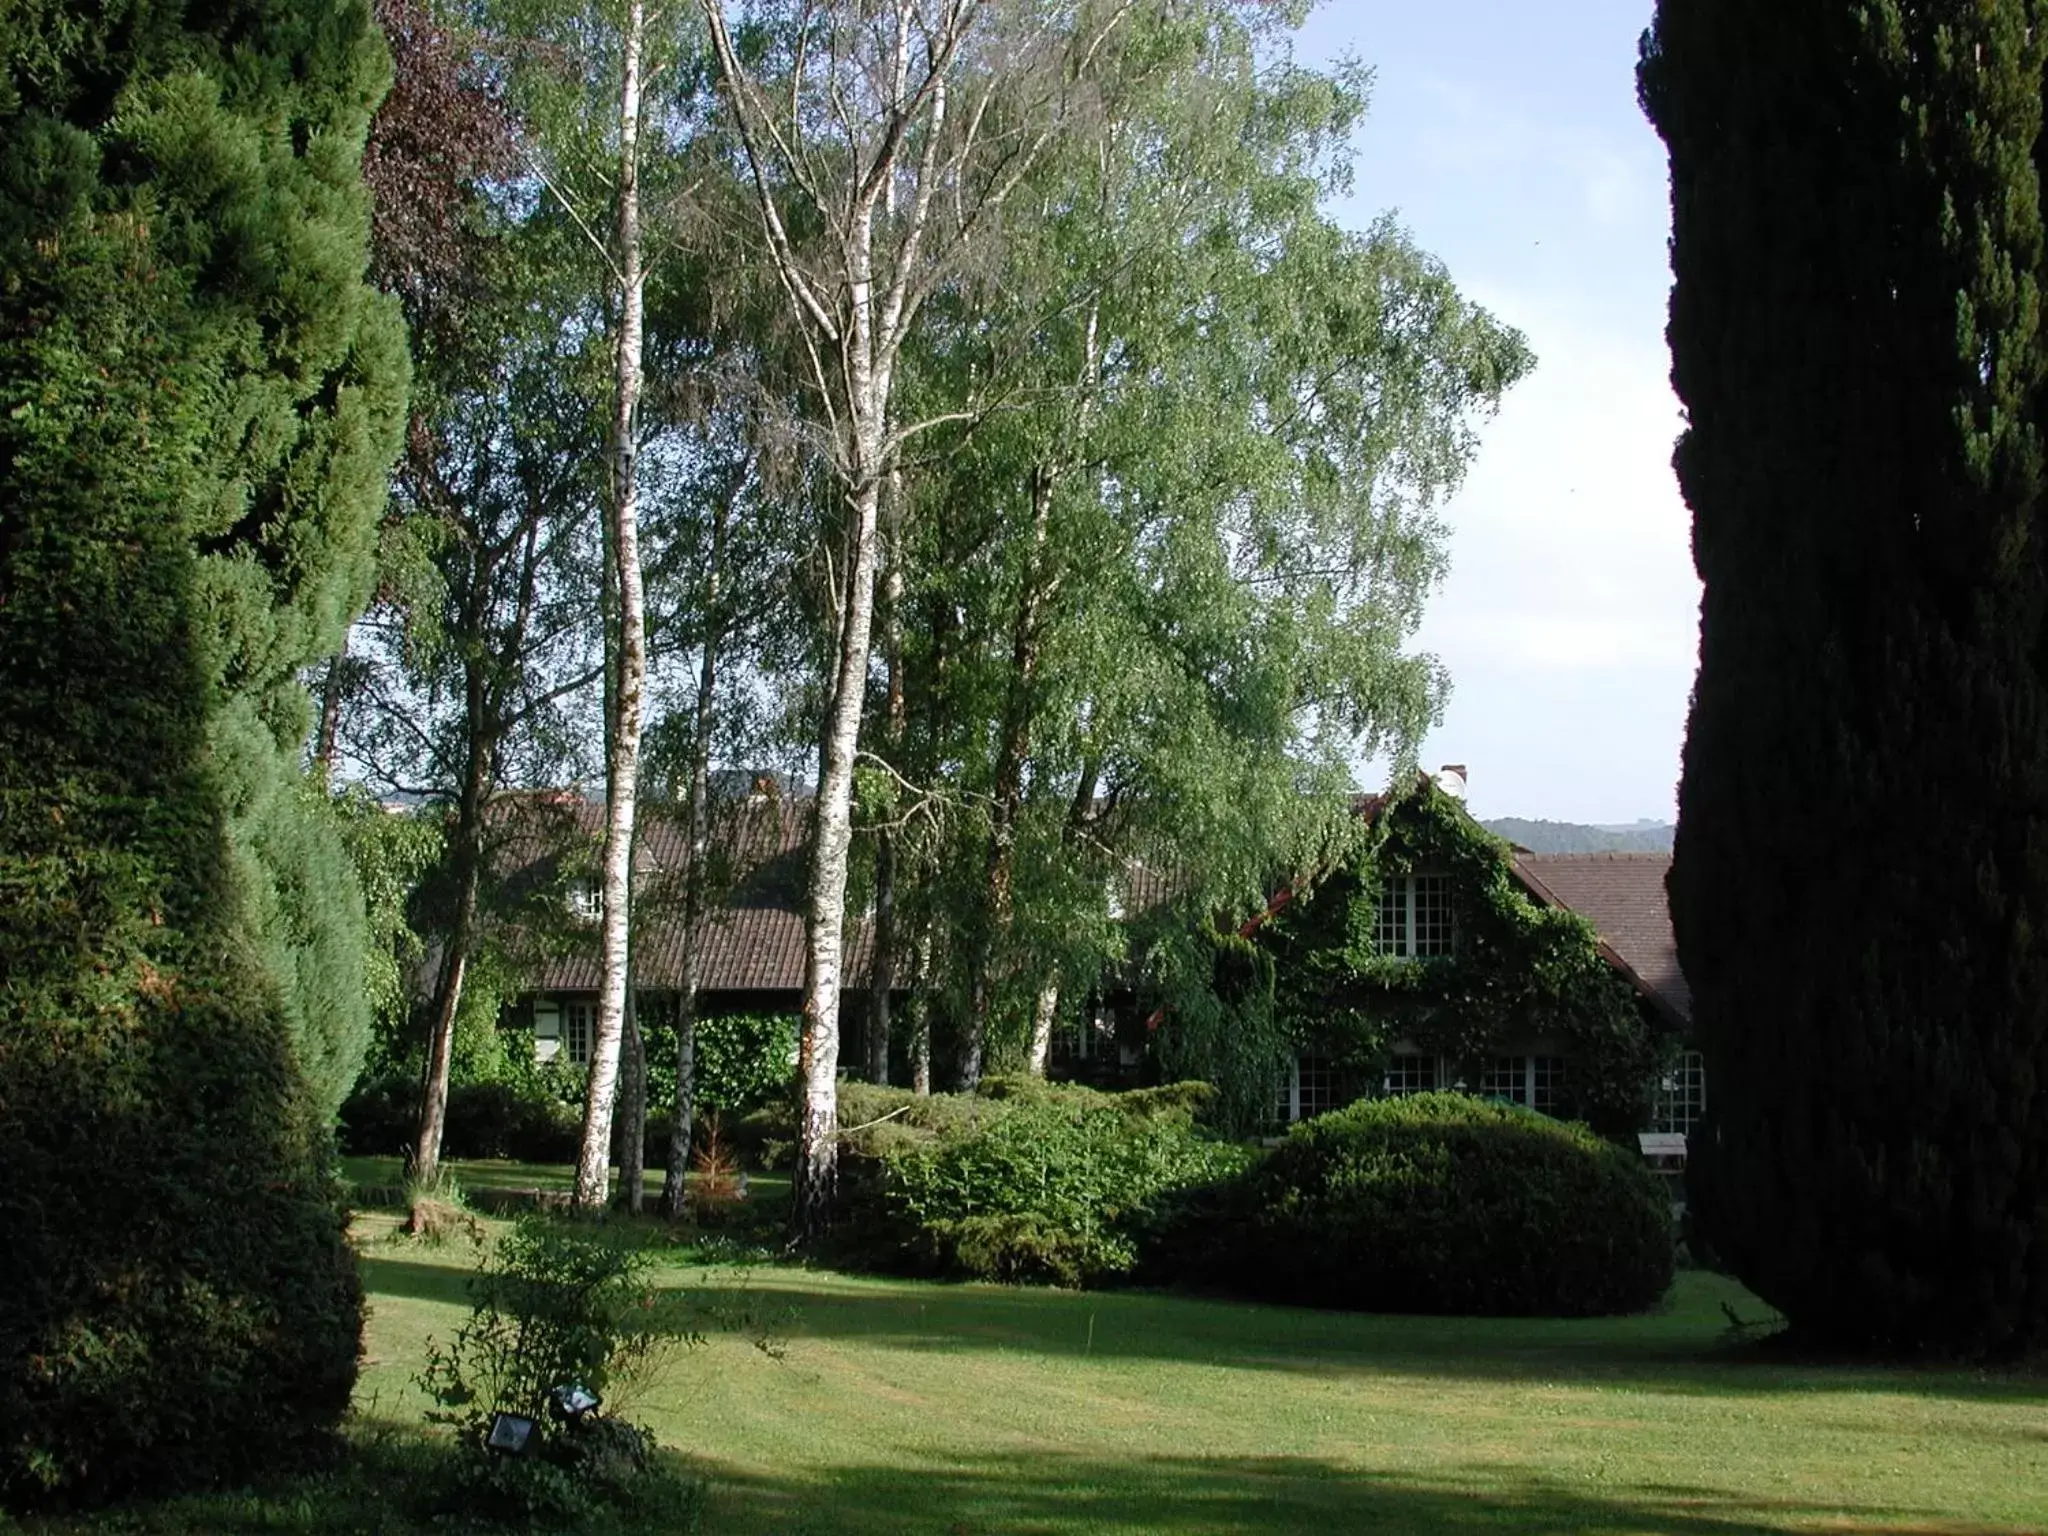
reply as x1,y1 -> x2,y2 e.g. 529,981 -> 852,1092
1296,0 -> 1700,821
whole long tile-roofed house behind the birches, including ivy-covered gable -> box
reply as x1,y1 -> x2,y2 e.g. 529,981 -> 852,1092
491,770 -> 1706,1137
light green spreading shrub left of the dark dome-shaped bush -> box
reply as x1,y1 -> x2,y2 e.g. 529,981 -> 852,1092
842,1079 -> 1243,1286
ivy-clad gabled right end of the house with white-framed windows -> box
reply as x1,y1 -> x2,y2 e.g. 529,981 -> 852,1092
1262,768 -> 1706,1155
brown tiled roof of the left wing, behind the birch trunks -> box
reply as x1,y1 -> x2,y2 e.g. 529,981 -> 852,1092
516,797 -> 872,993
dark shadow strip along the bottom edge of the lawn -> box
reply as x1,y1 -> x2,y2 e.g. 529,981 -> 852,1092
707,1454 -> 2017,1536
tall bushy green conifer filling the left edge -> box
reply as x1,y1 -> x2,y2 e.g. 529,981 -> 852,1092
0,0 -> 406,1503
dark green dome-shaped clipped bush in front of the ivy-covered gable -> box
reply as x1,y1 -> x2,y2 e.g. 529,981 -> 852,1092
1233,1094 -> 1673,1317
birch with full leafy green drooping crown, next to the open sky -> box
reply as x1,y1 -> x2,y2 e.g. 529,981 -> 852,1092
872,6 -> 1528,1087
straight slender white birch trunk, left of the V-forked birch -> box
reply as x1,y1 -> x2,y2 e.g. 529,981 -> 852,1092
575,0 -> 647,1210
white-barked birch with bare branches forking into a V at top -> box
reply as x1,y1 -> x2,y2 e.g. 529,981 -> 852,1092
698,0 -> 1128,1231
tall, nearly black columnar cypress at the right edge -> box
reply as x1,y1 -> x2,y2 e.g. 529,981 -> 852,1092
1640,0 -> 2048,1354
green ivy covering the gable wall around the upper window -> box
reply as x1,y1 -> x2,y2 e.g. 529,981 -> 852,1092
1257,778 -> 1673,1137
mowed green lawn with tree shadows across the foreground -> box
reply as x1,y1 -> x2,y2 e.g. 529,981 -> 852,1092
358,1217 -> 2048,1536
